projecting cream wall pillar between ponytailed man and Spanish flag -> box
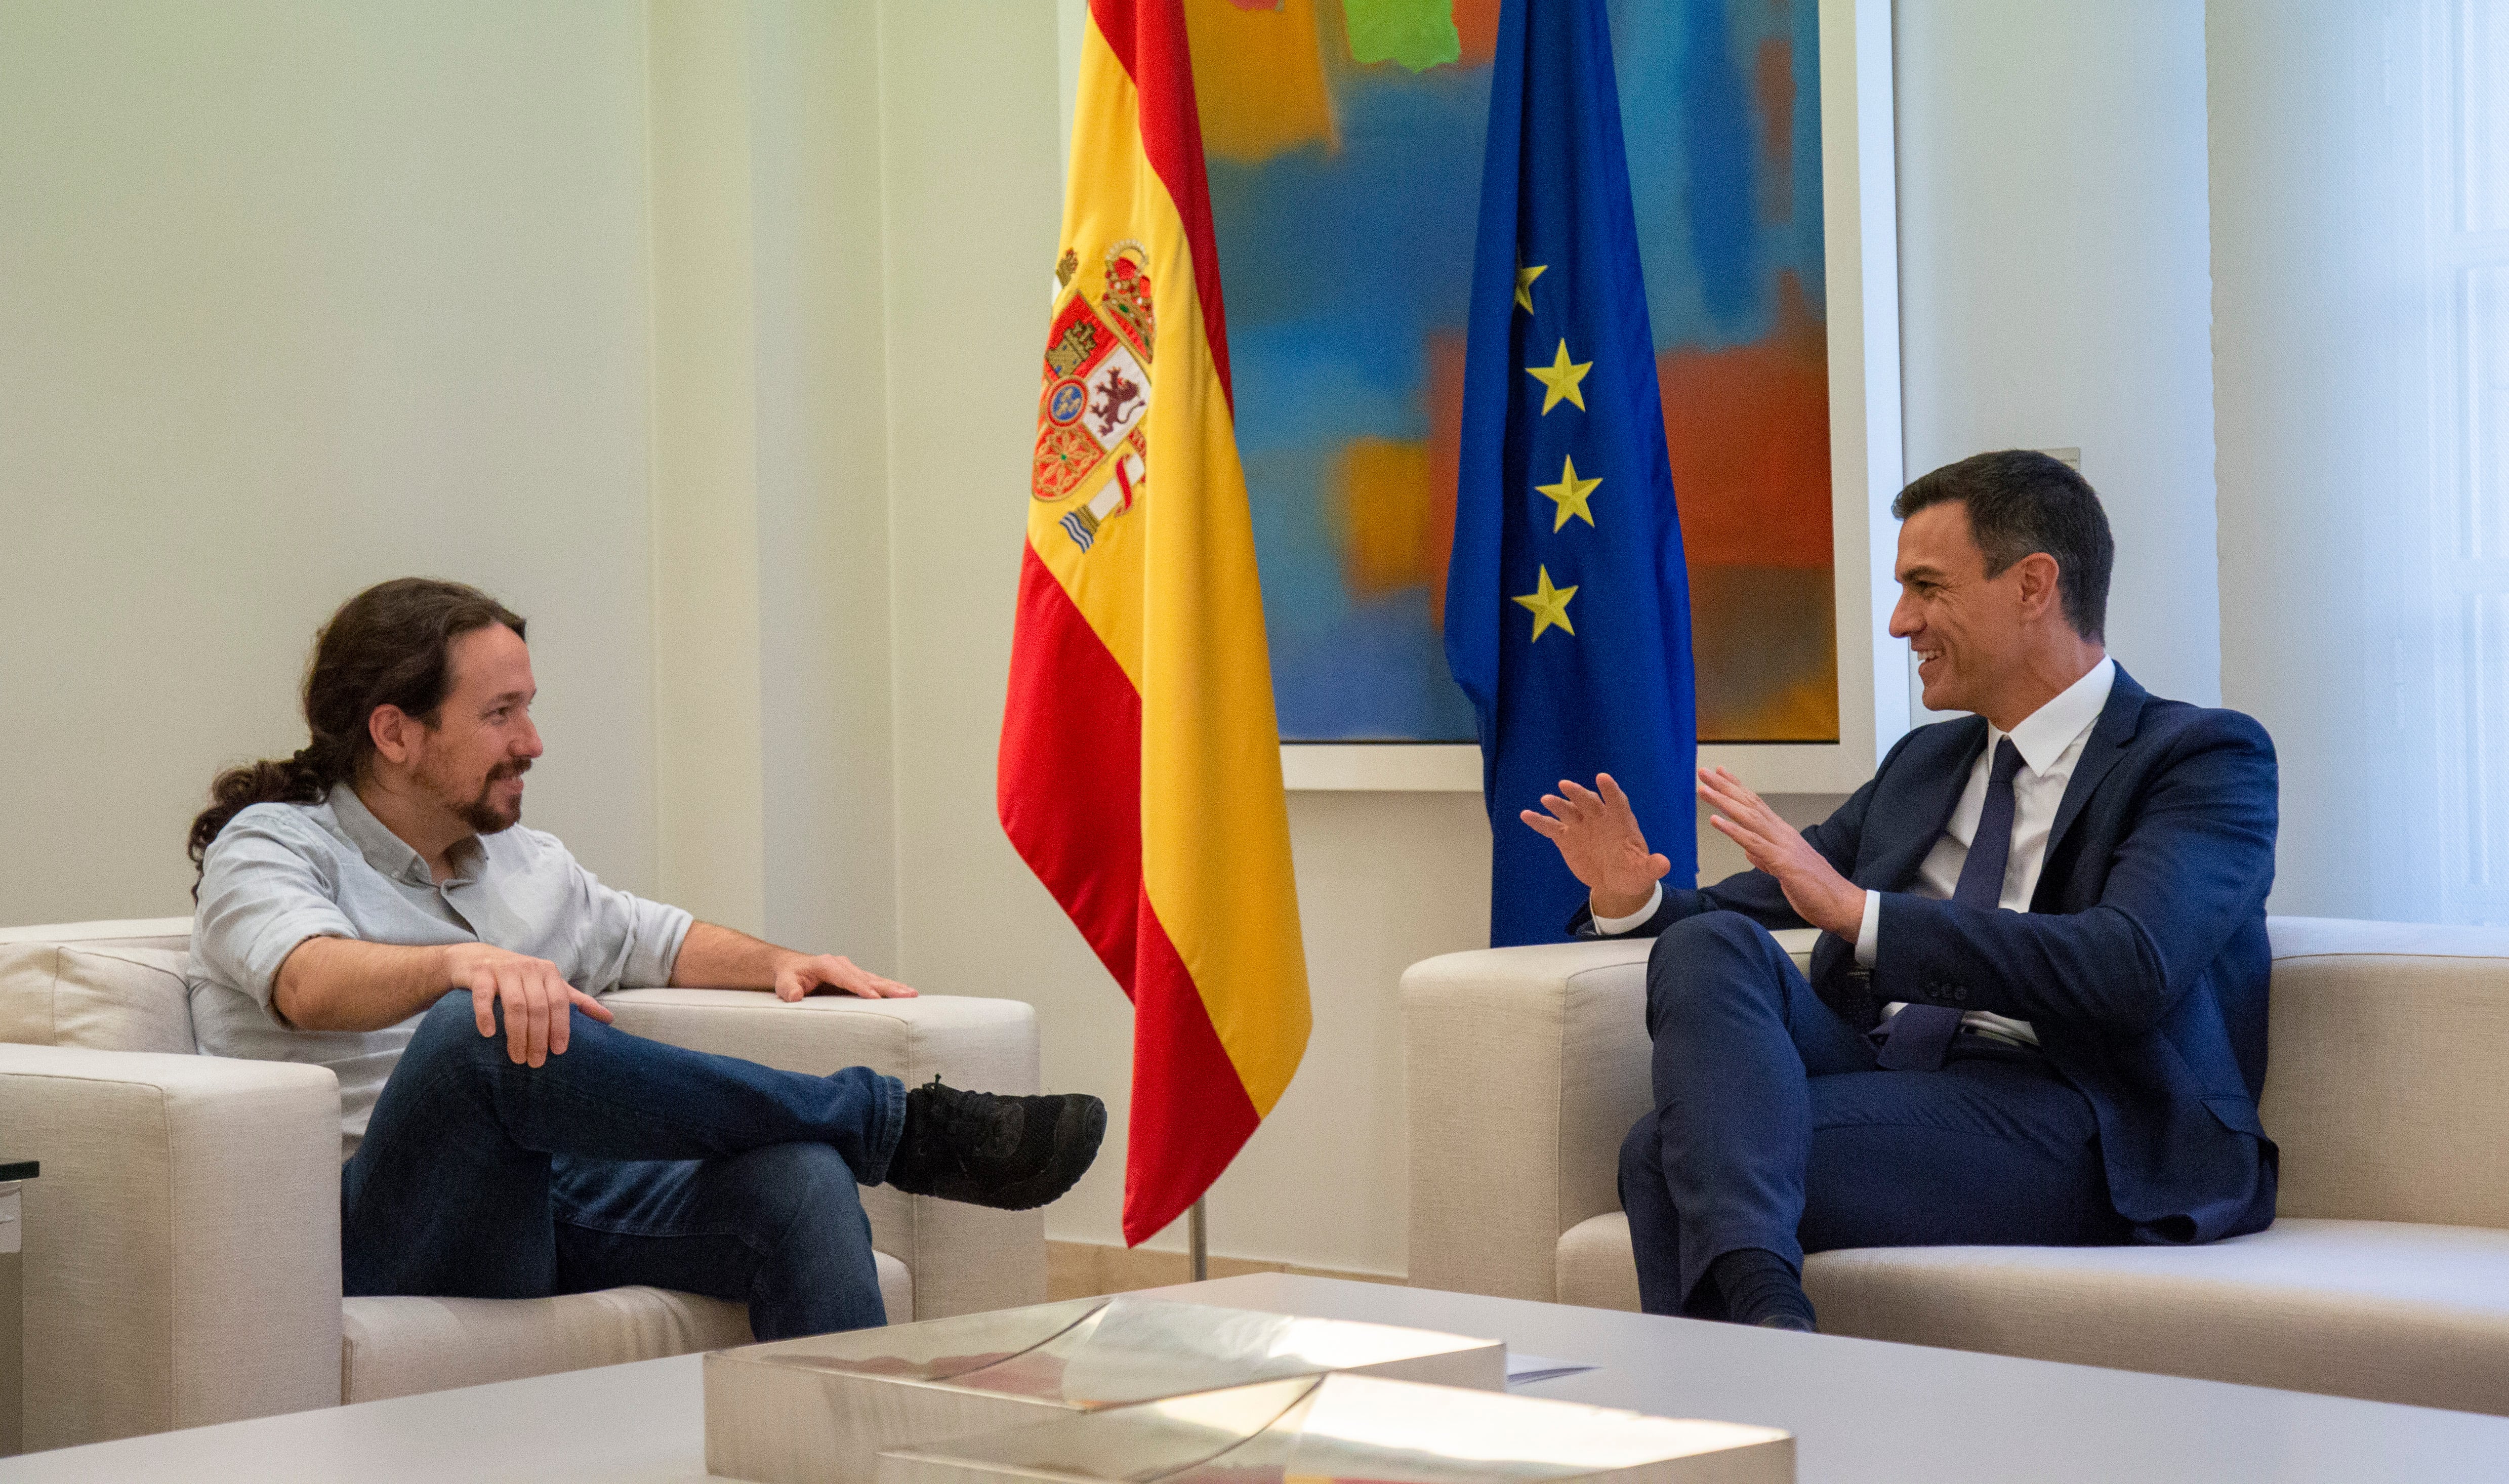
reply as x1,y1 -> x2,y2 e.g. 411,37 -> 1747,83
645,0 -> 898,972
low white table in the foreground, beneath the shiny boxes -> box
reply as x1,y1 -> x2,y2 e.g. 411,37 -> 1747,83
0,1273 -> 2509,1484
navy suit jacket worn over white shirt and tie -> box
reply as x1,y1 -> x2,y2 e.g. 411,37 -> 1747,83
1573,668 -> 2278,1243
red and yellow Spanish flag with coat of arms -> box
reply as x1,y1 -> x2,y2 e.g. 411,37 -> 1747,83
999,0 -> 1307,1243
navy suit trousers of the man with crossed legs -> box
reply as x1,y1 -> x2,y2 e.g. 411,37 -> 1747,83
1621,912 -> 2128,1318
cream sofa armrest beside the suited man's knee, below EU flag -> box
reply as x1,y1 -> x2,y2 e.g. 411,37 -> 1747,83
1403,932 -> 1817,1301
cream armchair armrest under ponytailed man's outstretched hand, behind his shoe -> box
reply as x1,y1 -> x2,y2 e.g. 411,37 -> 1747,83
602,990 -> 1046,1318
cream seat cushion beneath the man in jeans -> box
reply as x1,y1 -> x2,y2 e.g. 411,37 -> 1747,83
339,1253 -> 913,1401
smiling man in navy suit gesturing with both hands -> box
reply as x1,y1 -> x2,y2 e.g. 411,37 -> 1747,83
1523,452 -> 2276,1328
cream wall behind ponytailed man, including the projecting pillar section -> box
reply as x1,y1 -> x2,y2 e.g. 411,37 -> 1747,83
0,0 -> 896,967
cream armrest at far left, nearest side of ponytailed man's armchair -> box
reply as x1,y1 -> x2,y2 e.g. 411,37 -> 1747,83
0,1045 -> 339,1452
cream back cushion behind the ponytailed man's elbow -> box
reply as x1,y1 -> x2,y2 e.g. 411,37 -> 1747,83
0,939 -> 198,1055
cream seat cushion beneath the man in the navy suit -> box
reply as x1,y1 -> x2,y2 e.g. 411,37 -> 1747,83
1558,1213 -> 2509,1416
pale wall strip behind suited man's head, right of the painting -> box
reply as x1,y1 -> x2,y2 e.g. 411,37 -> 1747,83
1897,0 -> 2220,708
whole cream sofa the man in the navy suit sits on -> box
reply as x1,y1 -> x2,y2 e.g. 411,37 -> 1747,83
1403,917 -> 2509,1414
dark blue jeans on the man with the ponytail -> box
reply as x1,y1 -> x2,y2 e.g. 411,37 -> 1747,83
339,990 -> 906,1341
